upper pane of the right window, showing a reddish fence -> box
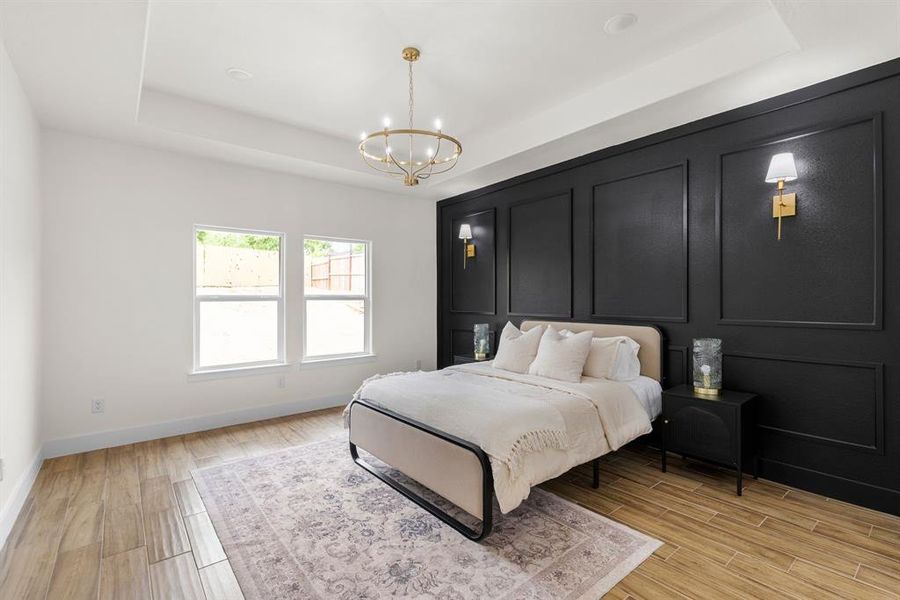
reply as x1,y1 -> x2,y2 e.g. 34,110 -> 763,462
303,238 -> 366,295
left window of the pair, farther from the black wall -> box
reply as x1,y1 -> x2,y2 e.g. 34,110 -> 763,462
194,226 -> 284,371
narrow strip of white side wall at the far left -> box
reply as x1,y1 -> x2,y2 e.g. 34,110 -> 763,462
0,42 -> 41,528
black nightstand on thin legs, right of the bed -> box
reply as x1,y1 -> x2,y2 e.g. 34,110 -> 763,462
662,385 -> 759,496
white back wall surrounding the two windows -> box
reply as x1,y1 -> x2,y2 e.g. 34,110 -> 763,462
42,131 -> 436,454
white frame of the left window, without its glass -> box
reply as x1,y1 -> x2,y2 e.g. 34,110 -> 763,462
191,224 -> 287,374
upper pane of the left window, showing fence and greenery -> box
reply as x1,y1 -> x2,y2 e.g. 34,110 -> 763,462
195,229 -> 281,296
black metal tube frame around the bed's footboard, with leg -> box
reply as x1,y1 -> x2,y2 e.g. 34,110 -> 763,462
350,399 -> 600,542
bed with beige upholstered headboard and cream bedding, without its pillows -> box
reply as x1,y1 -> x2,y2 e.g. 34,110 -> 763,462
345,321 -> 663,541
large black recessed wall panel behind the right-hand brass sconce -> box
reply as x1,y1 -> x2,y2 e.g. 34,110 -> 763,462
719,117 -> 882,328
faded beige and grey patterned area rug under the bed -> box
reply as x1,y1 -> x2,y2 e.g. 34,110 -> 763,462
193,437 -> 660,600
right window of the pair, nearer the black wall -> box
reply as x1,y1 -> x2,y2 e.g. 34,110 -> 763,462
303,238 -> 372,361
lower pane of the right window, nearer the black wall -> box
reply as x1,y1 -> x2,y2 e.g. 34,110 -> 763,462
306,300 -> 366,356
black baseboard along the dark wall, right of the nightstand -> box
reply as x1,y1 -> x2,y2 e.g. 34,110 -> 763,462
759,458 -> 900,516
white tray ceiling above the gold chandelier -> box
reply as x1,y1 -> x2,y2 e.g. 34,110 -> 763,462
0,0 -> 900,199
